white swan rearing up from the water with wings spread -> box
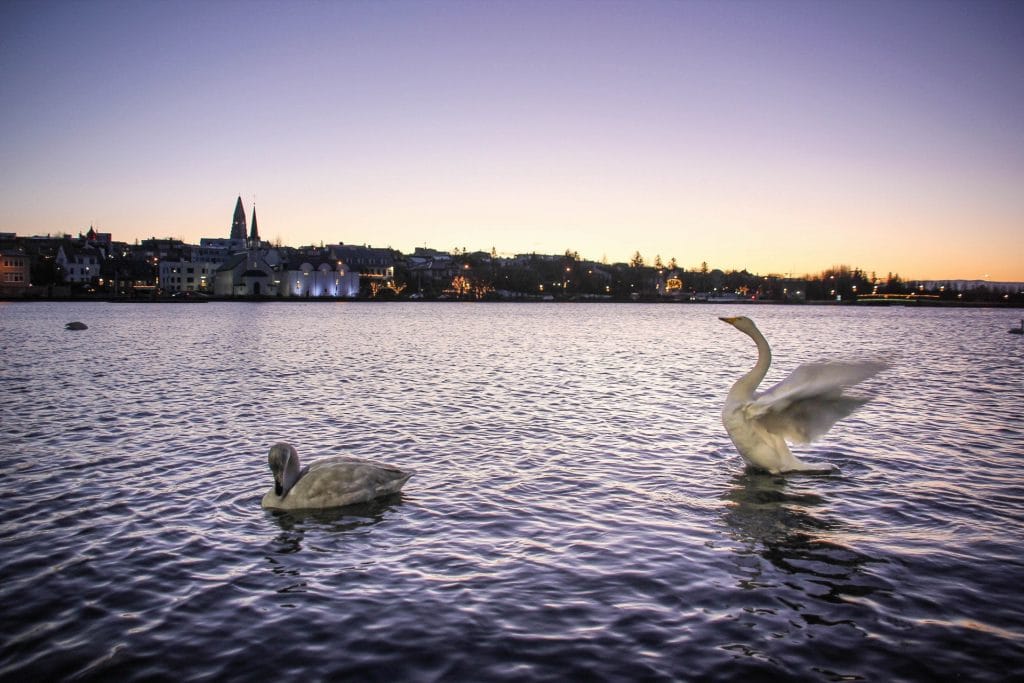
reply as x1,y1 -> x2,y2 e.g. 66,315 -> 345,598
719,315 -> 888,474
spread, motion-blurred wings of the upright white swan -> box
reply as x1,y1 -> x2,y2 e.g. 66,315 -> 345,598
744,361 -> 887,443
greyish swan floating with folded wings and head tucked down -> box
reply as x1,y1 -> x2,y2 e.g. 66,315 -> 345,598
261,442 -> 414,510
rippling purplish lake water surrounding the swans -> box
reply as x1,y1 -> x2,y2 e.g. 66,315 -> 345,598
0,303 -> 1024,681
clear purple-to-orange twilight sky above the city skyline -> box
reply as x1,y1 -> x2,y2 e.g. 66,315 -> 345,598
0,0 -> 1024,282
